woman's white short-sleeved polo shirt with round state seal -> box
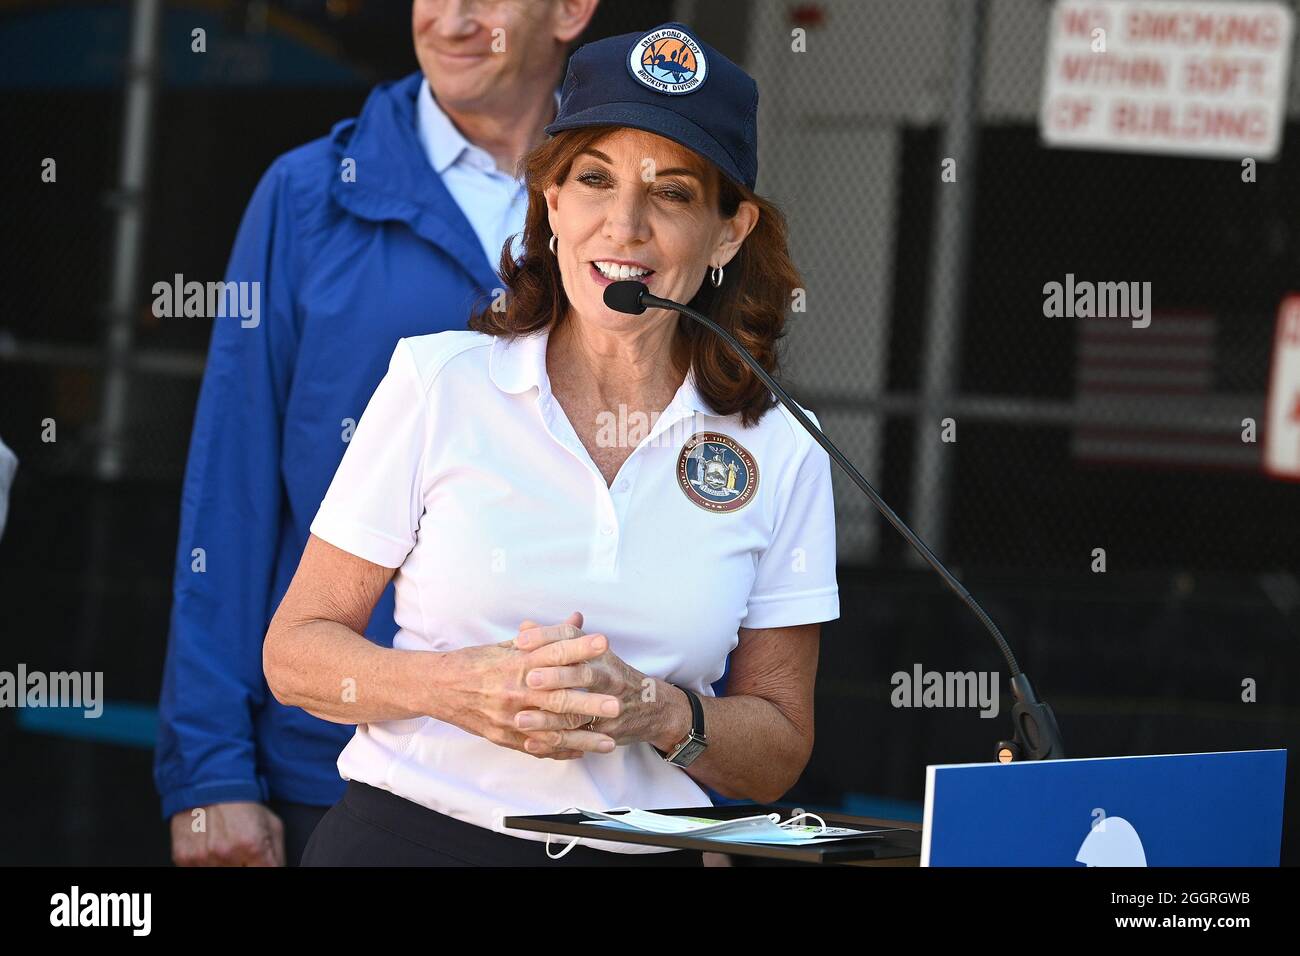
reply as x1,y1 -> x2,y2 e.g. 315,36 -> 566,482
311,323 -> 840,852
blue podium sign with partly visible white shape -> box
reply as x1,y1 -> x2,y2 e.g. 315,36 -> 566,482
920,750 -> 1287,866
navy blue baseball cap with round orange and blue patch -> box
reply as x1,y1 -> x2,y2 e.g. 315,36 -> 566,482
546,23 -> 758,189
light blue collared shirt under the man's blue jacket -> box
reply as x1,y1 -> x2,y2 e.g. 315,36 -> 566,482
416,81 -> 559,272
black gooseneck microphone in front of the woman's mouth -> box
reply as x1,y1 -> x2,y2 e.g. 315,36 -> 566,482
605,280 -> 1065,763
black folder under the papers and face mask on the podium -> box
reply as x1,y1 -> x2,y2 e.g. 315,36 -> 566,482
502,804 -> 920,866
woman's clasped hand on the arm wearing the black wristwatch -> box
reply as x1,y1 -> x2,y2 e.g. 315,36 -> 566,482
515,620 -> 689,749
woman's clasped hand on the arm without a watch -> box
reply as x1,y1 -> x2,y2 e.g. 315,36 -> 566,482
430,611 -> 619,760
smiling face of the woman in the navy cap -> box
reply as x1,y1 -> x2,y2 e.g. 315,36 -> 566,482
546,129 -> 758,328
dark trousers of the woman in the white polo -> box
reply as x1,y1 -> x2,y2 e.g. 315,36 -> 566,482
302,780 -> 703,866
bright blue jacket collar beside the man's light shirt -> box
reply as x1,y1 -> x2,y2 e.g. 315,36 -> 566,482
330,70 -> 501,290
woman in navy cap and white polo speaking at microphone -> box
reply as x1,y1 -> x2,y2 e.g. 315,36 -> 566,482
264,23 -> 840,865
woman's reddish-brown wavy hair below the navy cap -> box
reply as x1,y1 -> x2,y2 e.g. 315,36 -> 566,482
469,126 -> 801,427
